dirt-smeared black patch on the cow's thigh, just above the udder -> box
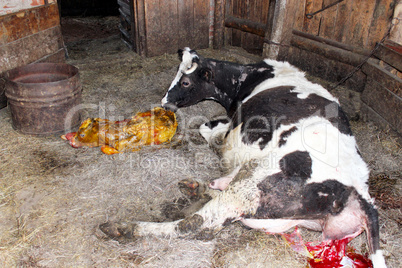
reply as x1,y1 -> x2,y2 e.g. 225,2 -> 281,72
256,177 -> 354,219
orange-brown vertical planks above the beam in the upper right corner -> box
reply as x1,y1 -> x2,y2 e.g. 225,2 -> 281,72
293,0 -> 396,50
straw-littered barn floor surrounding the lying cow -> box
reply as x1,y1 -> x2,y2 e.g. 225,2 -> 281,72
0,17 -> 402,268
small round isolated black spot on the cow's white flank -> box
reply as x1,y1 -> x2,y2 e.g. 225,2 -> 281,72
279,151 -> 312,179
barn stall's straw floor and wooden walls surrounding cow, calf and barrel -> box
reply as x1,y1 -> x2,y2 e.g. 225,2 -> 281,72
0,0 -> 402,267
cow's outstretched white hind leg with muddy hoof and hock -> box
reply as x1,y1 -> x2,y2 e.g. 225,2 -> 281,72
99,165 -> 258,243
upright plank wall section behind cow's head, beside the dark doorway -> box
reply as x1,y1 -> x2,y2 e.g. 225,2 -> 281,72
126,0 -> 210,56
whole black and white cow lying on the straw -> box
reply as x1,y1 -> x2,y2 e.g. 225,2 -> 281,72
102,48 -> 386,268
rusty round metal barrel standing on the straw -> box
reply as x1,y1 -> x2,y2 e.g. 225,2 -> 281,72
5,63 -> 82,135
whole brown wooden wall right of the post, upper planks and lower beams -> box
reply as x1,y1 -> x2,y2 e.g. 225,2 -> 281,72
277,0 -> 402,135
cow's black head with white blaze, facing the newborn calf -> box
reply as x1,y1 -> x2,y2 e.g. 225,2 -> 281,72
162,47 -> 215,111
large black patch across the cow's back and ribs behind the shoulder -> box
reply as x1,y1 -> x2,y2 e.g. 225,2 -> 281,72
232,86 -> 352,149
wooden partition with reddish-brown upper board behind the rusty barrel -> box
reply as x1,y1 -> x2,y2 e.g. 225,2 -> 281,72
0,3 -> 65,107
